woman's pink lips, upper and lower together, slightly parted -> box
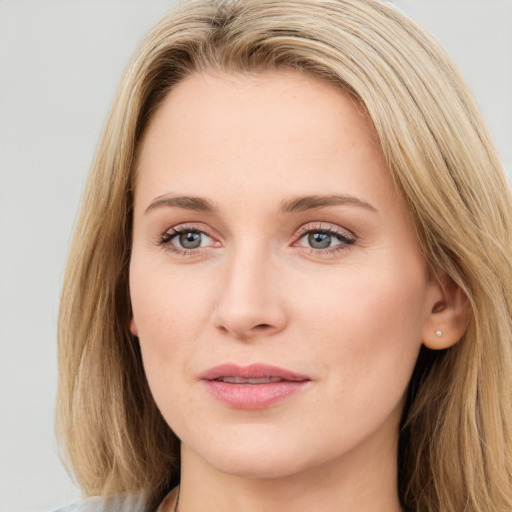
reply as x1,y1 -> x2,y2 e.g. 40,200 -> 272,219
200,364 -> 311,409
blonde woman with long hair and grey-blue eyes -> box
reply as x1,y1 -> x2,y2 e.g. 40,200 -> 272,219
58,0 -> 512,512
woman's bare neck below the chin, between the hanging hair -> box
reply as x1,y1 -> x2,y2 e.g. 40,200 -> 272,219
178,424 -> 401,512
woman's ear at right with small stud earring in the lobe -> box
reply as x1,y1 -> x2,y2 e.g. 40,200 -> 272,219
422,276 -> 470,350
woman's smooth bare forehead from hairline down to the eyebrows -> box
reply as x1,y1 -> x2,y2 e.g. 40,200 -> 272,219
136,70 -> 394,212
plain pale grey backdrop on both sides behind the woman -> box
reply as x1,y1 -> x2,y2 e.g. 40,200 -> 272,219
0,0 -> 512,512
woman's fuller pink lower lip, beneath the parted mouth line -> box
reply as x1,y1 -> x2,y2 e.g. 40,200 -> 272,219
203,380 -> 309,409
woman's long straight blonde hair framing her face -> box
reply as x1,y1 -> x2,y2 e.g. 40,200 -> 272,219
58,0 -> 512,512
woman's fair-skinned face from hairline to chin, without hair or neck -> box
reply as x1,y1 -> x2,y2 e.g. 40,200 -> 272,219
130,71 -> 440,477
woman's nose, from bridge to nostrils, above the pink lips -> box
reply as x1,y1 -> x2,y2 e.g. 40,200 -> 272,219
213,250 -> 288,341
